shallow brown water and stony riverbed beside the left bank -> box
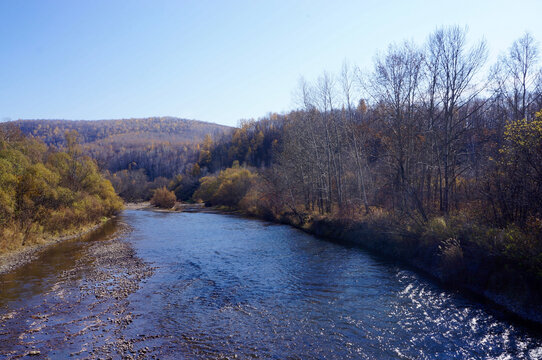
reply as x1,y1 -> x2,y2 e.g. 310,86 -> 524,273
0,222 -> 154,359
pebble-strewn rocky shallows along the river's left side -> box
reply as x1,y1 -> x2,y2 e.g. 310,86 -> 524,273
0,224 -> 160,359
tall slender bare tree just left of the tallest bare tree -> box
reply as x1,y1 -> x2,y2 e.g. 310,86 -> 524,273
367,43 -> 426,219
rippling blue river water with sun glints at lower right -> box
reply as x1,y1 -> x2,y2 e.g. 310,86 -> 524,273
0,211 -> 542,359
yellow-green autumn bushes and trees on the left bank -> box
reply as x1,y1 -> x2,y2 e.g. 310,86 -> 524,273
0,124 -> 122,253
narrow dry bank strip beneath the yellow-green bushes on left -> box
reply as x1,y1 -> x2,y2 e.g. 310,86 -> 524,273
0,218 -> 113,274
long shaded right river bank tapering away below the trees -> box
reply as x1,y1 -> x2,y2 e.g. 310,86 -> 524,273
196,206 -> 542,325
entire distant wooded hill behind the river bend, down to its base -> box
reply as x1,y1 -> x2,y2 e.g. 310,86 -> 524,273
0,117 -> 233,201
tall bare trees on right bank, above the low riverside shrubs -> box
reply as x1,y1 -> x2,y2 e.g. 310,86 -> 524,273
191,27 -> 542,231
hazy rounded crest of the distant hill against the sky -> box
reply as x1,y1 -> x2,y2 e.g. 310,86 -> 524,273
8,117 -> 231,147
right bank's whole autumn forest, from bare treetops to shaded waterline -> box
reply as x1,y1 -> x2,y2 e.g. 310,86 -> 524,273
183,27 -> 542,305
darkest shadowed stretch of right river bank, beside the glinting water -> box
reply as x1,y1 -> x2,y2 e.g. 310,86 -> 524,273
294,219 -> 542,324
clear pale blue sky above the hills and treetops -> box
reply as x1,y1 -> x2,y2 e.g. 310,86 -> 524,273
0,0 -> 542,125
